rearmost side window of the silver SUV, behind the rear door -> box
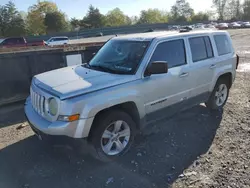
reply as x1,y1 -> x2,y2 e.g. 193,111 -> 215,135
214,35 -> 232,56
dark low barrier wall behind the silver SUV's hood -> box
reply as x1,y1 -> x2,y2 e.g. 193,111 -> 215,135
0,43 -> 101,105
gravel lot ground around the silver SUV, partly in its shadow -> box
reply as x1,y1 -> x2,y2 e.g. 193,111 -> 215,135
0,30 -> 250,188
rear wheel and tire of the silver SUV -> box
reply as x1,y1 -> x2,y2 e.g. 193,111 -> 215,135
205,78 -> 230,110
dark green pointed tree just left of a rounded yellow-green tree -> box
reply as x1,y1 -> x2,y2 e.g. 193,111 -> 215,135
83,5 -> 105,28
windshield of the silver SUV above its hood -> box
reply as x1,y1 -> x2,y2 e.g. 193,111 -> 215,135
89,40 -> 149,74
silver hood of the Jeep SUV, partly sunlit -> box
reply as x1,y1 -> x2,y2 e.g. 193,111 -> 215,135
34,65 -> 135,99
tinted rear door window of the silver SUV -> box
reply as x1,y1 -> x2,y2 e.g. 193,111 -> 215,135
189,36 -> 214,62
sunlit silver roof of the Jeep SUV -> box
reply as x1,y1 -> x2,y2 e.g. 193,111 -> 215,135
115,29 -> 226,41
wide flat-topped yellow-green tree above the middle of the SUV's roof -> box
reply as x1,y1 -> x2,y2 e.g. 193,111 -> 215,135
138,9 -> 168,24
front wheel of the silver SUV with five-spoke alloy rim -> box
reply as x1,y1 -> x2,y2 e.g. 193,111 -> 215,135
89,110 -> 136,162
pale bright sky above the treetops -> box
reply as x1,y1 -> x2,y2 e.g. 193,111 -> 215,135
0,0 -> 212,18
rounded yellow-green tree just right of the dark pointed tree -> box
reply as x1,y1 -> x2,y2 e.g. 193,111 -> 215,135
105,8 -> 131,26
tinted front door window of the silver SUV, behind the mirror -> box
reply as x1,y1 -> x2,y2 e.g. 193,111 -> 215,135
150,39 -> 186,68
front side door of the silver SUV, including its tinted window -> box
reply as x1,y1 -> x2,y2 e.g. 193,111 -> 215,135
143,39 -> 190,122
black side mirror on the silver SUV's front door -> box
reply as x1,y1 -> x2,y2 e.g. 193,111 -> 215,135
144,61 -> 168,76
